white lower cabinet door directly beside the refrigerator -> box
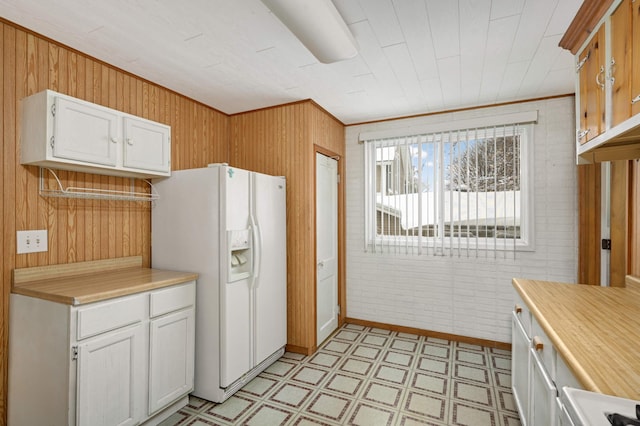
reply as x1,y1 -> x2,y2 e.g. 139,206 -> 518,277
149,308 -> 195,414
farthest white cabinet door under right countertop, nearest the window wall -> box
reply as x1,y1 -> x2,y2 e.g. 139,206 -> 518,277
511,311 -> 531,426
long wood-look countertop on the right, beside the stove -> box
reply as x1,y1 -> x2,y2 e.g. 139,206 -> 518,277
513,277 -> 640,400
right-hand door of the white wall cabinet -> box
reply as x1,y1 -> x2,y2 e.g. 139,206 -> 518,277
123,117 -> 171,172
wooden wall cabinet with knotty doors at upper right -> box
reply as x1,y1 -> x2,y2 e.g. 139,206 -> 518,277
561,0 -> 640,163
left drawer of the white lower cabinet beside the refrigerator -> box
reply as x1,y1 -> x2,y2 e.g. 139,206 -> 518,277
77,295 -> 147,340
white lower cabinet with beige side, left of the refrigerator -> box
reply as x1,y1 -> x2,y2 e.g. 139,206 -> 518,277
8,281 -> 195,426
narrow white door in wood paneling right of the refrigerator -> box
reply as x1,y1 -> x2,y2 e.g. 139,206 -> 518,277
316,153 -> 339,345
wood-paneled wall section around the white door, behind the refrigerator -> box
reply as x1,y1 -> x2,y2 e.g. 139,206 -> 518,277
229,101 -> 344,353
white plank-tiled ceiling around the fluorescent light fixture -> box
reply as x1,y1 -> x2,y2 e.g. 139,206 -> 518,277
0,0 -> 581,124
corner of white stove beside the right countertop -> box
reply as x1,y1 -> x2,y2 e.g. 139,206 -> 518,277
560,386 -> 640,426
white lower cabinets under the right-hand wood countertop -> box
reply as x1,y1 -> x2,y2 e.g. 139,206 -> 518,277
511,297 -> 582,426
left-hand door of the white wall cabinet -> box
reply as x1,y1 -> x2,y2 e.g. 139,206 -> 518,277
49,97 -> 119,166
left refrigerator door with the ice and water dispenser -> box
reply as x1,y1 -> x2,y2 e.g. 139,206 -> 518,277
220,167 -> 254,388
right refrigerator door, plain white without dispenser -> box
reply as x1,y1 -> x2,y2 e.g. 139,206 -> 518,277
252,173 -> 287,365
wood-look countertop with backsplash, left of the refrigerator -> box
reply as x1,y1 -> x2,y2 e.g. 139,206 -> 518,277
11,256 -> 198,306
